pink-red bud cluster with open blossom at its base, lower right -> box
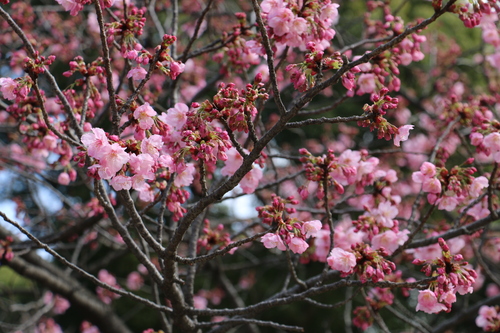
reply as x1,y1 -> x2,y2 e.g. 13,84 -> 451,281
413,238 -> 477,313
